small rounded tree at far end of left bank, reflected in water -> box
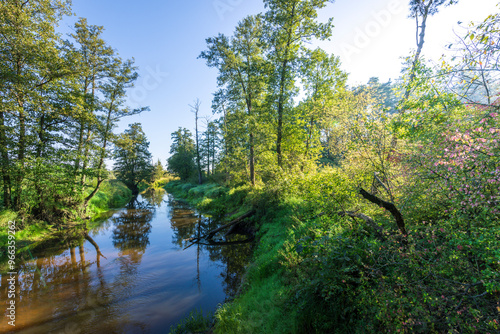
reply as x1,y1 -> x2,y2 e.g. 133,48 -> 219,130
114,123 -> 152,195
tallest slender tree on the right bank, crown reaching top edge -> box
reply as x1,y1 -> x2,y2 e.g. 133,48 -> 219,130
264,0 -> 333,167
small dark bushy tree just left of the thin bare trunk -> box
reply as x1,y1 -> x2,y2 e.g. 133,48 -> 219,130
167,128 -> 197,180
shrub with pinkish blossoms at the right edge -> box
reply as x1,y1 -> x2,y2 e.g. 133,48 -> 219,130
420,112 -> 500,218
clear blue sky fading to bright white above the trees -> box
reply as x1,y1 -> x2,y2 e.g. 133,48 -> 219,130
61,0 -> 498,164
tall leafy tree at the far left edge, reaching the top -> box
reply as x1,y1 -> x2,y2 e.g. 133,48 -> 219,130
0,0 -> 69,210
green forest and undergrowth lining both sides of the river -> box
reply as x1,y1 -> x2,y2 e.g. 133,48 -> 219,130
0,0 -> 500,333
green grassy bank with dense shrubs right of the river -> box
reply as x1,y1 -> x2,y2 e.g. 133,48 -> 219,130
167,169 -> 500,333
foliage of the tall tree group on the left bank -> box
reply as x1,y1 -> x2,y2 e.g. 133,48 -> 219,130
0,0 -> 144,222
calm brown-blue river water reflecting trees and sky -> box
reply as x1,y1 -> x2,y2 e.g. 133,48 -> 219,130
0,192 -> 252,334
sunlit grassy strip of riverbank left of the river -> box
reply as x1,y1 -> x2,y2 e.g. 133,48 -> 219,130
0,179 -> 132,263
